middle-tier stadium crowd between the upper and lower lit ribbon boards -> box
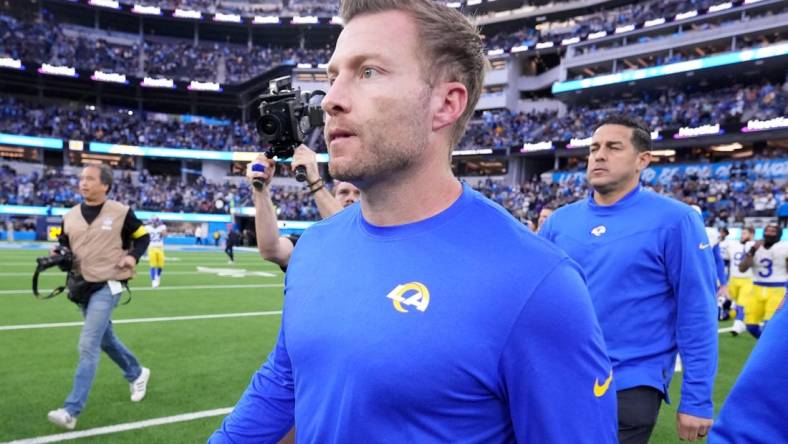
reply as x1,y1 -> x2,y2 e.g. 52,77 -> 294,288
0,83 -> 788,151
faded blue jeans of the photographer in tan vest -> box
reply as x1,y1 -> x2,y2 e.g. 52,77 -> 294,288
63,285 -> 142,417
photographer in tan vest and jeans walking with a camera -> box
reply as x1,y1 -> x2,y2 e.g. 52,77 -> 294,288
47,164 -> 150,429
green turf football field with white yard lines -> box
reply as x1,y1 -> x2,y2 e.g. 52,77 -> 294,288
0,249 -> 754,443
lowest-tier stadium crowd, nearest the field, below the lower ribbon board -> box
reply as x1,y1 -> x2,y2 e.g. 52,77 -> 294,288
0,159 -> 788,226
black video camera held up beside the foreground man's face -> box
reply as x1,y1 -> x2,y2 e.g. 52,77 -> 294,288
252,76 -> 326,184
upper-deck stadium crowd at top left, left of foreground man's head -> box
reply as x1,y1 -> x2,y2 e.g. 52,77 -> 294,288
0,14 -> 330,83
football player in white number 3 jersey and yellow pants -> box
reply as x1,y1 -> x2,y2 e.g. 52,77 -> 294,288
739,224 -> 788,338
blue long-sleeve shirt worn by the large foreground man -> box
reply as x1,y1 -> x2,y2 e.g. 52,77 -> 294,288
210,185 -> 617,444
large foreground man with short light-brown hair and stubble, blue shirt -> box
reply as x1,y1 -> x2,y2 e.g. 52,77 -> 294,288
210,0 -> 616,444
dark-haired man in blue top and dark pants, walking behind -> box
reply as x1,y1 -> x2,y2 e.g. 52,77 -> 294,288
540,116 -> 717,443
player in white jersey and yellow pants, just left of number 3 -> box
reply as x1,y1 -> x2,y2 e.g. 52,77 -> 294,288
720,227 -> 755,335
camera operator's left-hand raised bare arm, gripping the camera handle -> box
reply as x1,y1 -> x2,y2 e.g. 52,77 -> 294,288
246,155 -> 293,269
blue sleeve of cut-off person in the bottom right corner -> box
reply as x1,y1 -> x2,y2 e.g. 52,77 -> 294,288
709,308 -> 788,444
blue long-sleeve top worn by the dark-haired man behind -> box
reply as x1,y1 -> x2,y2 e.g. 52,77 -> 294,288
541,186 -> 717,418
